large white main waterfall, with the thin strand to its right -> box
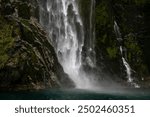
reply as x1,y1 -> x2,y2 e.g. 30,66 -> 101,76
40,0 -> 95,88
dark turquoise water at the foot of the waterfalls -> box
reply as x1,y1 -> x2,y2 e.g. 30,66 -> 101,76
0,89 -> 150,100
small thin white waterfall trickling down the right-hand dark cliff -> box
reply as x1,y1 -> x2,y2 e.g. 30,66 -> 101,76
114,21 -> 140,88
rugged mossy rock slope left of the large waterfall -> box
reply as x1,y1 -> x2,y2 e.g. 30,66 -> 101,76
0,0 -> 73,90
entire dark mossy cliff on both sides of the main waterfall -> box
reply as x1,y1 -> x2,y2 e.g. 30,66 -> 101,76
0,0 -> 150,90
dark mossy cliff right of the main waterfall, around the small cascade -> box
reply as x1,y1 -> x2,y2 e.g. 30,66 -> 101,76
96,0 -> 150,87
